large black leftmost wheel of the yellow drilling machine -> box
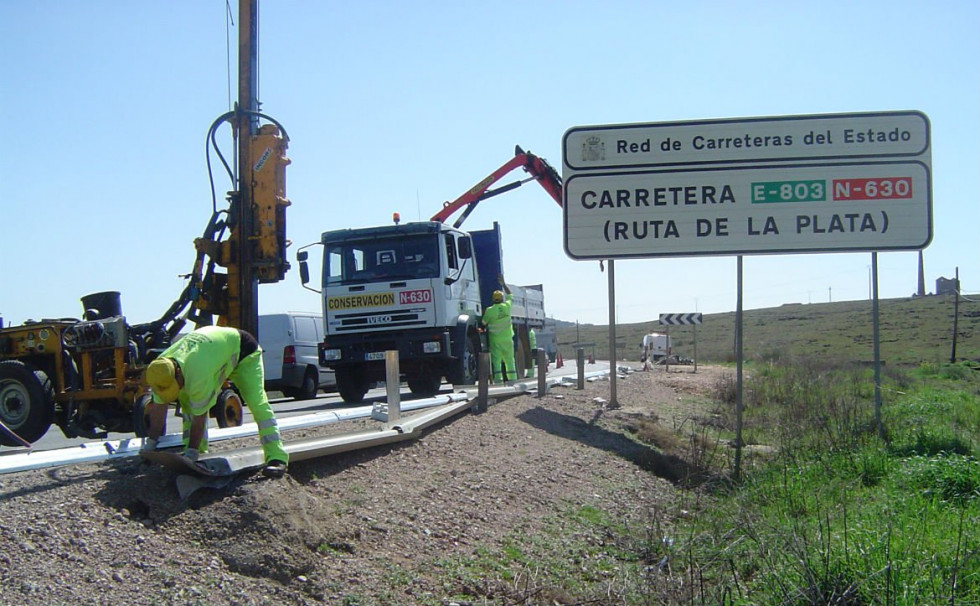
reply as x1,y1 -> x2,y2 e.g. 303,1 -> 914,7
0,360 -> 54,446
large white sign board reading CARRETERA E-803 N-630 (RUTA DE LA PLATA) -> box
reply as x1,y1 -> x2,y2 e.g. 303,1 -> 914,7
563,112 -> 932,259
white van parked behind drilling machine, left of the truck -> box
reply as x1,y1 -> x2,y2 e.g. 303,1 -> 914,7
258,312 -> 337,400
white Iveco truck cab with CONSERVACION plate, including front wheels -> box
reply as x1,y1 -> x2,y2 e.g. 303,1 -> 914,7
320,222 -> 483,402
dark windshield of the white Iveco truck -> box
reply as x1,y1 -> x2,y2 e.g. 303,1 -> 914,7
323,234 -> 439,285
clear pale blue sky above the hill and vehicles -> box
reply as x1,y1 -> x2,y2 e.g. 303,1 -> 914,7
0,0 -> 980,330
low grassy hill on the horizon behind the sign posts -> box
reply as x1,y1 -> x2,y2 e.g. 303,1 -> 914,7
557,295 -> 980,365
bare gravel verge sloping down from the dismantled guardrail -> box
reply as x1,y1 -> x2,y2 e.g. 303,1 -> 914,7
0,366 -> 729,605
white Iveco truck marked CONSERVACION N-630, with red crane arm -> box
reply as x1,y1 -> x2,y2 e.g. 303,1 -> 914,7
297,147 -> 561,403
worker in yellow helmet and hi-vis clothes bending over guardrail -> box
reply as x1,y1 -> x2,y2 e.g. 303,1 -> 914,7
144,326 -> 289,477
